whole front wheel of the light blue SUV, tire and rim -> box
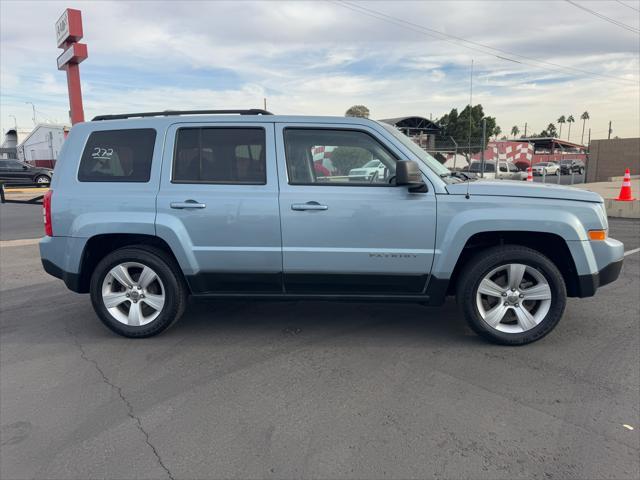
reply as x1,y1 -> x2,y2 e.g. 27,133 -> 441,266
458,245 -> 567,345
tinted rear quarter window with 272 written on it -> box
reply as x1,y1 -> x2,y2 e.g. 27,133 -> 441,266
78,128 -> 156,182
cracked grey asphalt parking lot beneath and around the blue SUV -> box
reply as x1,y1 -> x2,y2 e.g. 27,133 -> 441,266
0,201 -> 640,479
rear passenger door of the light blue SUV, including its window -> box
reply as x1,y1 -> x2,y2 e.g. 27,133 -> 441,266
156,122 -> 282,294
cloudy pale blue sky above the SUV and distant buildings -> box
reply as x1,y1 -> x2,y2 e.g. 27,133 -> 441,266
0,0 -> 640,140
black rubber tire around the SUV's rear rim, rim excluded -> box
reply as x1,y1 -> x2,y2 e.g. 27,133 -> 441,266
90,245 -> 188,338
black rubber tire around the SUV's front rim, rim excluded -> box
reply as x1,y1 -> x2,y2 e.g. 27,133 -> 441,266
457,245 -> 567,345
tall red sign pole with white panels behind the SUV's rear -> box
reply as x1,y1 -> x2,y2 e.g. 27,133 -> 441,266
56,8 -> 88,125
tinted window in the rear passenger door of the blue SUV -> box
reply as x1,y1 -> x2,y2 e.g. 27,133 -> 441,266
172,127 -> 267,185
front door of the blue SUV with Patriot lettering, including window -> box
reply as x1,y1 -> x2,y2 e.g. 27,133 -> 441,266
276,124 -> 436,295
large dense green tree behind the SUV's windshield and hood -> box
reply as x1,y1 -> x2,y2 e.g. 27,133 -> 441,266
437,104 -> 497,162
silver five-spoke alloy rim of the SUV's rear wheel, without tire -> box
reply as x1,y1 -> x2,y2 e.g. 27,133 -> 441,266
102,262 -> 166,327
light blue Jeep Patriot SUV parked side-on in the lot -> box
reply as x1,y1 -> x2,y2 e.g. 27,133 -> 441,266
40,110 -> 623,345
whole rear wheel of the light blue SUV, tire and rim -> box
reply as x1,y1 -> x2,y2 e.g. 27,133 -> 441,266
90,247 -> 187,338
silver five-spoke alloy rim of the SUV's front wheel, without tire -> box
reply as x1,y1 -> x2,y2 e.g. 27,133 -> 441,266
476,263 -> 553,333
